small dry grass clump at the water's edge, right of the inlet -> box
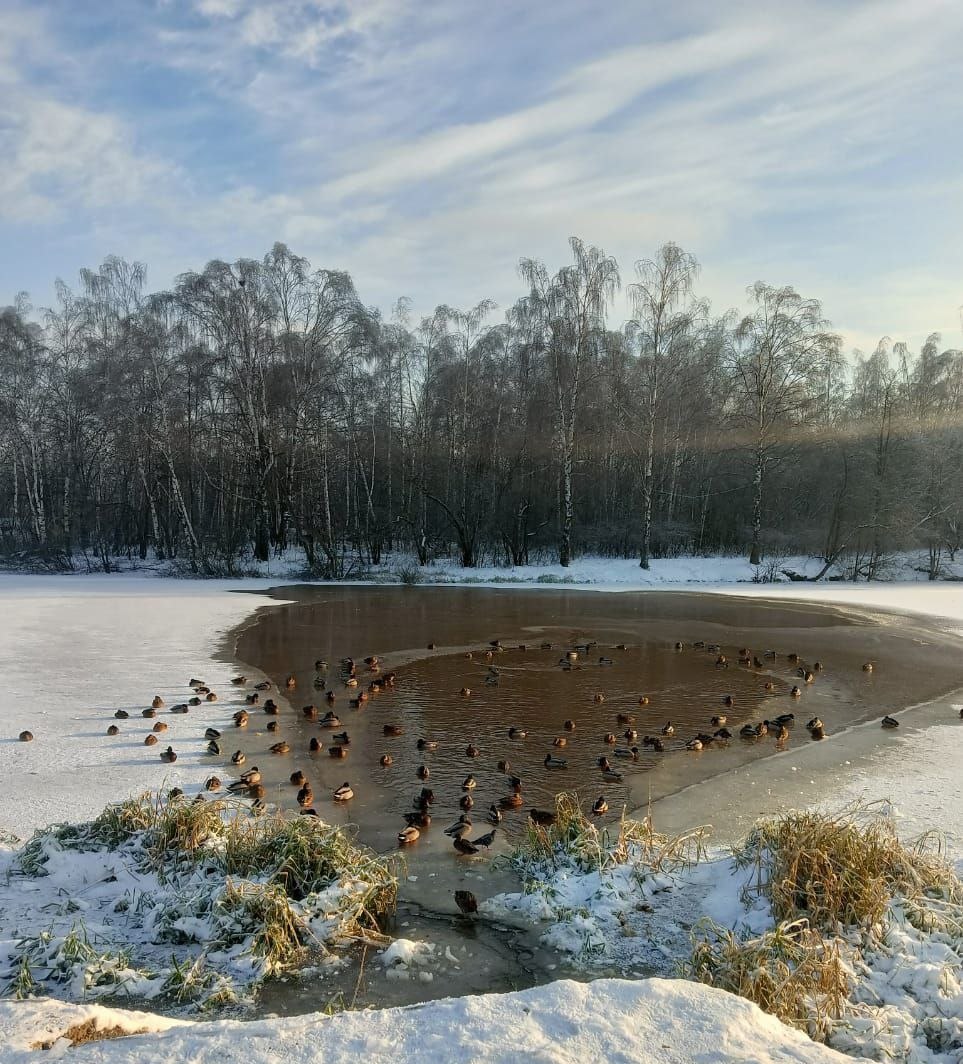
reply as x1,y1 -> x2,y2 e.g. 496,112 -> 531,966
516,792 -> 707,871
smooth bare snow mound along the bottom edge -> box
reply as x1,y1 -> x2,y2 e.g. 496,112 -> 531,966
0,979 -> 847,1064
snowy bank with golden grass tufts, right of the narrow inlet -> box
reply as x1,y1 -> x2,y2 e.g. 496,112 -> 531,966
482,795 -> 963,1064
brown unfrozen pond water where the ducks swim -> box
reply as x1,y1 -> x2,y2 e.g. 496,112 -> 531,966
216,586 -> 963,1011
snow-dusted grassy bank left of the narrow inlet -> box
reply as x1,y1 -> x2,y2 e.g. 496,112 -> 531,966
0,795 -> 397,1009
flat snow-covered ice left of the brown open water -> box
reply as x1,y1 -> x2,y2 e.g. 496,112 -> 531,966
0,573 -> 293,837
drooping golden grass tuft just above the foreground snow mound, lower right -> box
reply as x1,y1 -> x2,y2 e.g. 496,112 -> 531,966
685,919 -> 850,1042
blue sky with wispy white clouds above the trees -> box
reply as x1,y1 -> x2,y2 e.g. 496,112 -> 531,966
0,0 -> 963,349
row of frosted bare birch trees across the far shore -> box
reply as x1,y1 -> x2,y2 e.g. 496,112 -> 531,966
0,239 -> 963,579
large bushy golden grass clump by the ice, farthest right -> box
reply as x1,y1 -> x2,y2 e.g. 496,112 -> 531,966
735,805 -> 963,930
